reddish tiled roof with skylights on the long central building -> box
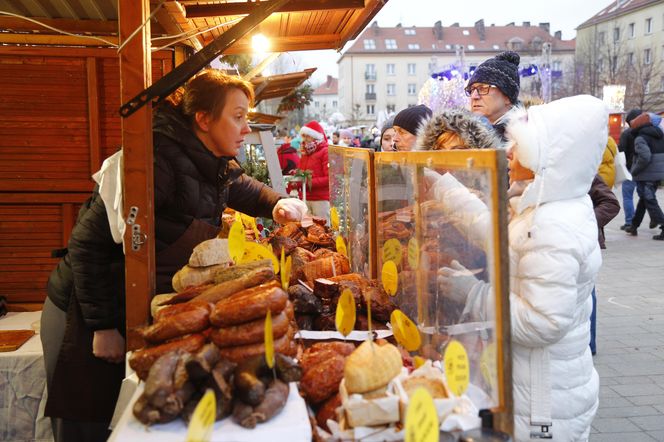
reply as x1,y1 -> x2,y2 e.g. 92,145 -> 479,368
342,21 -> 576,58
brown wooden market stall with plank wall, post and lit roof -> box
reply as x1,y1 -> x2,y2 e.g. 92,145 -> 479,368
0,0 -> 385,342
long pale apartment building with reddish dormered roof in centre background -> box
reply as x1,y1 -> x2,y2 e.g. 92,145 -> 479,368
338,20 -> 575,125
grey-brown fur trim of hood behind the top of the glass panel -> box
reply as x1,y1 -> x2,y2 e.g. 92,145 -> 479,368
415,110 -> 502,150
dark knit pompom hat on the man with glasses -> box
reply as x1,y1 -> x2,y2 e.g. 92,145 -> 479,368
468,51 -> 521,104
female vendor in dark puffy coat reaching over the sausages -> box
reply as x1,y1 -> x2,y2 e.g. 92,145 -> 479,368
41,70 -> 306,442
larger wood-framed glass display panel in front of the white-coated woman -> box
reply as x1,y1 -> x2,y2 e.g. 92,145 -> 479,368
374,149 -> 511,429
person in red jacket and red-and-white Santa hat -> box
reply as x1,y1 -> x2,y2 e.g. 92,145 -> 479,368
300,121 -> 330,221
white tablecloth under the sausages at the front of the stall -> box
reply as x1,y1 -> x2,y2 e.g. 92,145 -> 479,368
108,383 -> 311,442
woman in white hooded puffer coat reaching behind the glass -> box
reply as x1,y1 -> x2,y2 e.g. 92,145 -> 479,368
420,95 -> 608,441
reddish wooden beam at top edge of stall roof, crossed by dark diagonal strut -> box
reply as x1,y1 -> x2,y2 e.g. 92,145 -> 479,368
185,0 -> 364,18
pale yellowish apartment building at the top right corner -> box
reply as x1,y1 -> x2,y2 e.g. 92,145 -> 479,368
576,0 -> 664,111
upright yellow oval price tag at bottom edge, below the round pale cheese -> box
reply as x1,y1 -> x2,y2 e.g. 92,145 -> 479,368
406,387 -> 440,442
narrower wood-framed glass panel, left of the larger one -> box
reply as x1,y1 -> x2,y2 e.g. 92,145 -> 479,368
328,146 -> 376,278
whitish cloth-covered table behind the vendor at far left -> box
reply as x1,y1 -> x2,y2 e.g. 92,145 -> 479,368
0,312 -> 53,442
